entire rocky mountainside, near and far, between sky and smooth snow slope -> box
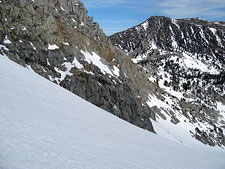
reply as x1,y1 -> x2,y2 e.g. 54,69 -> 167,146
0,0 -> 225,147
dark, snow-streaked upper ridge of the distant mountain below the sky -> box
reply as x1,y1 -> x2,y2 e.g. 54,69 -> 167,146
110,17 -> 225,60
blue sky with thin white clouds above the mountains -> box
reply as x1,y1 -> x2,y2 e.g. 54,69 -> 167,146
81,0 -> 225,35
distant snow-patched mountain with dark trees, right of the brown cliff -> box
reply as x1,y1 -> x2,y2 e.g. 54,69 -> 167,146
110,17 -> 225,146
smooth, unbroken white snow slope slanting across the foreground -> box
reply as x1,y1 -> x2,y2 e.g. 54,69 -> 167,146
0,55 -> 225,169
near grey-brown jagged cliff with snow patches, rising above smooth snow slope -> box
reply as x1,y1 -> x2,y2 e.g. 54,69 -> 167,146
0,0 -> 154,132
